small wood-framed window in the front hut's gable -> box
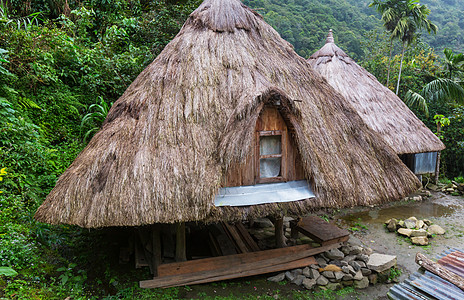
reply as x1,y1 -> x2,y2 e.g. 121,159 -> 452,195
258,130 -> 285,183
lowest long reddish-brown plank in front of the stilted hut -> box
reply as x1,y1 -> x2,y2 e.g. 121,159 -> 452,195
161,256 -> 317,288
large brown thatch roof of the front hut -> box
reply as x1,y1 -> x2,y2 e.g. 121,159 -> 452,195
35,0 -> 419,227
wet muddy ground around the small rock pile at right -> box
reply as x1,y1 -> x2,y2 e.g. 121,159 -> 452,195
334,193 -> 464,299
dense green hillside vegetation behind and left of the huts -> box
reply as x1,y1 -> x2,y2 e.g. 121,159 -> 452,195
0,0 -> 464,299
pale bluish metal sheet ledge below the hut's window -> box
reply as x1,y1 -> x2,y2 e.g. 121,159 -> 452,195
214,180 -> 315,206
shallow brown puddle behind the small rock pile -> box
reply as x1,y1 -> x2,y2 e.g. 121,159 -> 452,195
340,202 -> 460,225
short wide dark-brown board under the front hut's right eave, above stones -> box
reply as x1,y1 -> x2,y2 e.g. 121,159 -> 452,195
295,216 -> 350,243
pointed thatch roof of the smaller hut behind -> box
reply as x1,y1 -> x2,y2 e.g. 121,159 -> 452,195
309,30 -> 445,154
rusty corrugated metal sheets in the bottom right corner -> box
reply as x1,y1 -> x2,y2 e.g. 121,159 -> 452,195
388,248 -> 464,300
